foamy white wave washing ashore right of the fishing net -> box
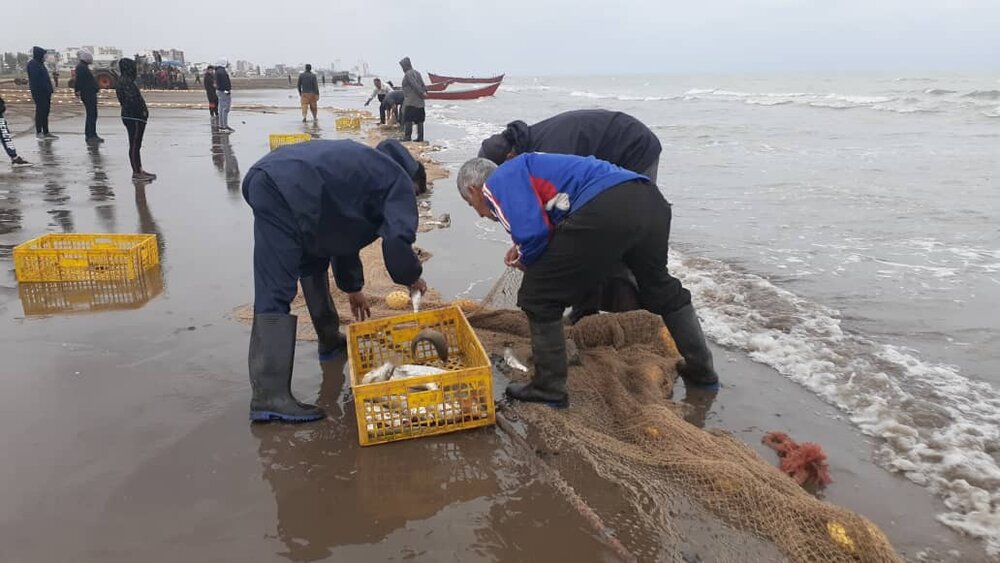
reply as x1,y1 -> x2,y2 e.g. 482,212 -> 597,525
671,250 -> 1000,556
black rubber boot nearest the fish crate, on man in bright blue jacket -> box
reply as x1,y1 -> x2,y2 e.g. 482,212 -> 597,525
507,319 -> 569,409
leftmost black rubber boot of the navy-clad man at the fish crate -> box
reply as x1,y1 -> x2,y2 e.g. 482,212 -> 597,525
250,314 -> 326,422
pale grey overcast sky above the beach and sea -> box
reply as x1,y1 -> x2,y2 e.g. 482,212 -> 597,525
0,0 -> 1000,75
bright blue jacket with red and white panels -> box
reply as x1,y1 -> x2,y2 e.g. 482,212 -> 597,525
483,153 -> 648,267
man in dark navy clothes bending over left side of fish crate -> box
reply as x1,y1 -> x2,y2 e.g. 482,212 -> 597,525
243,141 -> 427,422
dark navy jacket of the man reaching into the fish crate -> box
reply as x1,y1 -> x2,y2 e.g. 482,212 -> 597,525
243,140 -> 423,292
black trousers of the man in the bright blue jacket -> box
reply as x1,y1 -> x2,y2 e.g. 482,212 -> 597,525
517,181 -> 691,322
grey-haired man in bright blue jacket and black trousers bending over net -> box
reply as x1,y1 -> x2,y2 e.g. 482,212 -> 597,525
458,153 -> 719,407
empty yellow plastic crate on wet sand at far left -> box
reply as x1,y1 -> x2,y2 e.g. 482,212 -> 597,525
14,234 -> 160,282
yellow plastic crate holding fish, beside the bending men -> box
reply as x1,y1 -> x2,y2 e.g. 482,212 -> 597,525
347,306 -> 496,446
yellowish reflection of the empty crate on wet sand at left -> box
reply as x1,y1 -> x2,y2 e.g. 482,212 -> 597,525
17,266 -> 163,317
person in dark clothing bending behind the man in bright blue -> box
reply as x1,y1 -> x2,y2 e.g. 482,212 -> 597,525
479,109 -> 661,324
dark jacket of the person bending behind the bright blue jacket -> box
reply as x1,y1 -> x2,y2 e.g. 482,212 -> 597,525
479,109 -> 662,174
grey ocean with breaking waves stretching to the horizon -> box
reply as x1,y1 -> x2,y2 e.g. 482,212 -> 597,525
416,74 -> 1000,554
